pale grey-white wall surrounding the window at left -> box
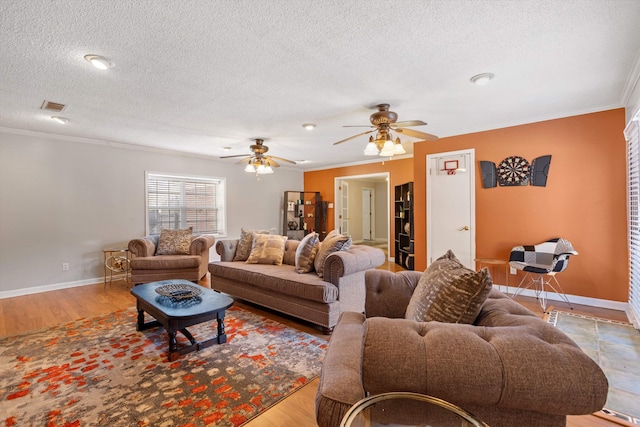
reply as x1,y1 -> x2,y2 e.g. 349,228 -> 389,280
0,128 -> 304,298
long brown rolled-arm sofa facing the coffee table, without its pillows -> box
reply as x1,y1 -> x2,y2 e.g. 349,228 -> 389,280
209,239 -> 385,333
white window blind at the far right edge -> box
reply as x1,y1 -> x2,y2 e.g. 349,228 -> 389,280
624,113 -> 640,329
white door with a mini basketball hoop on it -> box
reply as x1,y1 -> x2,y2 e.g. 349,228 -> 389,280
427,150 -> 476,270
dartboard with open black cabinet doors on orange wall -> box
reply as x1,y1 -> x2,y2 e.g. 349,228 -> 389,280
480,155 -> 551,188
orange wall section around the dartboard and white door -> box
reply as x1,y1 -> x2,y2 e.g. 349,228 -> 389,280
414,108 -> 629,302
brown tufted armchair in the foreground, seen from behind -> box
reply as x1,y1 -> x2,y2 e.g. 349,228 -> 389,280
316,270 -> 608,427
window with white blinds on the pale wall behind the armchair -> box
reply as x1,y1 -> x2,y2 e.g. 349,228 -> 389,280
146,172 -> 227,236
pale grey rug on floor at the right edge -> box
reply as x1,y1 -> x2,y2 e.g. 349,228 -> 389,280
549,310 -> 640,425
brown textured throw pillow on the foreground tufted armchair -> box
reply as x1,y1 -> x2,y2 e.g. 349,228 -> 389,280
405,250 -> 492,324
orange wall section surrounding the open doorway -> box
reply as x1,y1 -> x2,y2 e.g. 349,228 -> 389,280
304,159 -> 413,256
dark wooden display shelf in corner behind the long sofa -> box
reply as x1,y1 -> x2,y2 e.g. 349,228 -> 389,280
282,191 -> 327,240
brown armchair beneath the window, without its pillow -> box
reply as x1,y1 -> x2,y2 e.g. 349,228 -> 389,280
129,234 -> 216,284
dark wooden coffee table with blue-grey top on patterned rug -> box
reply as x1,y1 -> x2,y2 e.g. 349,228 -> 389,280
131,280 -> 233,362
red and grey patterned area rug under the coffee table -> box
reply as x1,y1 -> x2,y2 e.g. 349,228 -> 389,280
0,307 -> 327,427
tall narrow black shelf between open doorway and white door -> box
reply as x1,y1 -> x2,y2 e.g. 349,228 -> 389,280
394,182 -> 414,270
